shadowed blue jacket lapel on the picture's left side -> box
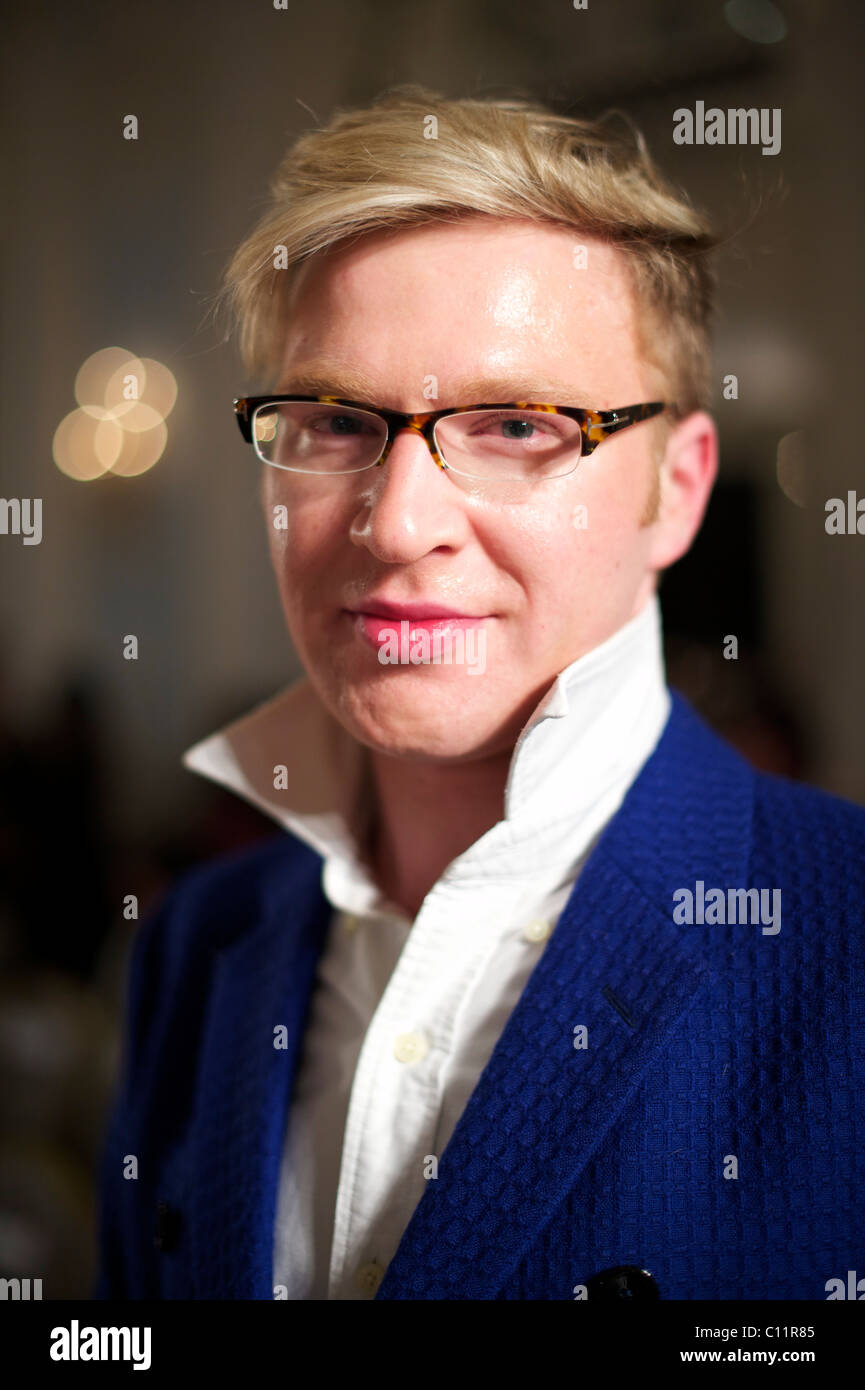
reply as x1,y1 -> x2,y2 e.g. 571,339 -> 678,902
189,844 -> 331,1298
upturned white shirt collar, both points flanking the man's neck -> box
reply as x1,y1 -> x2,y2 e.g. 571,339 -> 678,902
182,595 -> 669,863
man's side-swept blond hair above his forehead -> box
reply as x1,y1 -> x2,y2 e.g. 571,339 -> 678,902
216,83 -> 716,418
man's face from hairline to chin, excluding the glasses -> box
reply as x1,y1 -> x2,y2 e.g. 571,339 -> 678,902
261,218 -> 706,760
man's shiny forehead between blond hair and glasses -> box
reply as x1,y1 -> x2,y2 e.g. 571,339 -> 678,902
273,218 -> 645,410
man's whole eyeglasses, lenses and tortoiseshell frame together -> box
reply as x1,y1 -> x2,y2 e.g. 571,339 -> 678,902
234,395 -> 668,482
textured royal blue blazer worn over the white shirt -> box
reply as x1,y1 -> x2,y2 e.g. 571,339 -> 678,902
95,694 -> 865,1300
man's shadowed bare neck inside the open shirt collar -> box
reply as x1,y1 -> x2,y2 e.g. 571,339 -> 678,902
369,749 -> 512,919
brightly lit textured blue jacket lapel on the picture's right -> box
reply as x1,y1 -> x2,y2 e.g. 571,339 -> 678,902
377,695 -> 754,1300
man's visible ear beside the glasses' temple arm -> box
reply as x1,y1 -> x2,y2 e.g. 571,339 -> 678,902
648,410 -> 718,570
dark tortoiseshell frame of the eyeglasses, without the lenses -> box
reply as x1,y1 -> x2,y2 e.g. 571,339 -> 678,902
234,392 -> 669,473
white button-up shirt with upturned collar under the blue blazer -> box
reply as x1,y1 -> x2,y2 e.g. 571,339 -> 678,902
184,596 -> 670,1300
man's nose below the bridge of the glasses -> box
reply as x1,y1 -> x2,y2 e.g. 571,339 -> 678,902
350,425 -> 467,564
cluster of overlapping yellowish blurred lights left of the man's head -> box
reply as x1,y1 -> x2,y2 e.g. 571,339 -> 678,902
61,346 -> 177,482
